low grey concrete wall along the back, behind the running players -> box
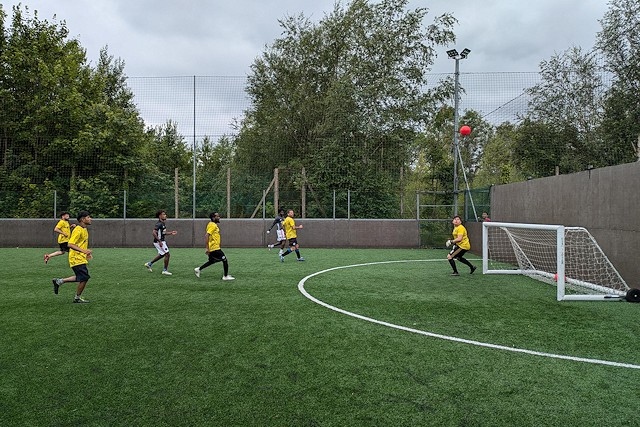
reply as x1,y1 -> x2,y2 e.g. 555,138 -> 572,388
0,218 -> 420,248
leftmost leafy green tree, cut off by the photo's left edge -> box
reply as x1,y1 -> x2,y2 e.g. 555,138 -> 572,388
0,7 -> 89,216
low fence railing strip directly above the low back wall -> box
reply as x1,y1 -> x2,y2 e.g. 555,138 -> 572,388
0,188 -> 490,221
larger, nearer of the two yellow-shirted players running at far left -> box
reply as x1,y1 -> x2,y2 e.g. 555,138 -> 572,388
52,211 -> 93,303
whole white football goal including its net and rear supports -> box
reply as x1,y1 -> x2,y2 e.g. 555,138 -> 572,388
482,222 -> 629,301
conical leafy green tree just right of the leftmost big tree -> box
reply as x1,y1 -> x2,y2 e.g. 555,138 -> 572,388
66,49 -> 152,217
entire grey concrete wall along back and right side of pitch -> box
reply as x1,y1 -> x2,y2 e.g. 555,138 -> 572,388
0,162 -> 640,287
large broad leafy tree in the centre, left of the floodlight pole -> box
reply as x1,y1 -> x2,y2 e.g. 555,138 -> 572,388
237,0 -> 455,217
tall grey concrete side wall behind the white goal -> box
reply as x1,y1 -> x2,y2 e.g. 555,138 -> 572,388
488,162 -> 640,288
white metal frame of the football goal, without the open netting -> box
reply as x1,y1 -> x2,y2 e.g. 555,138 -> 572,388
482,221 -> 629,301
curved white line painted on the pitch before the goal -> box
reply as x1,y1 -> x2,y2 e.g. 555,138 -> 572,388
298,259 -> 640,369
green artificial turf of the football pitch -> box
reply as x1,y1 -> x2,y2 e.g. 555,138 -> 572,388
0,248 -> 640,427
